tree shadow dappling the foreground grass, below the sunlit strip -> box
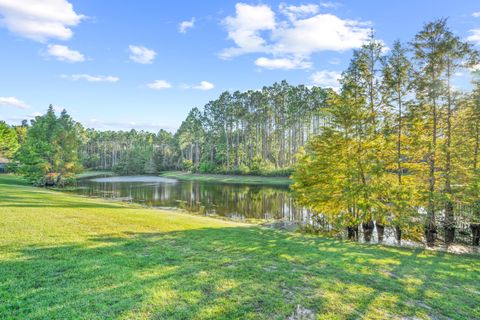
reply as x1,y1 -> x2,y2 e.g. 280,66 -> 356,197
0,227 -> 480,319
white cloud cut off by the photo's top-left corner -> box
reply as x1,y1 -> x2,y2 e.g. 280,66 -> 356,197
0,0 -> 85,42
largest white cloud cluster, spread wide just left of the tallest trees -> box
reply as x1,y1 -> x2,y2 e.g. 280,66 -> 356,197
220,3 -> 371,69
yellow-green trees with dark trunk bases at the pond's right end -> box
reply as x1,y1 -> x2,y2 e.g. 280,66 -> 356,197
293,19 -> 480,246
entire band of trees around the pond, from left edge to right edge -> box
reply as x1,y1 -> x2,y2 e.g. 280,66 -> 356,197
0,19 -> 480,245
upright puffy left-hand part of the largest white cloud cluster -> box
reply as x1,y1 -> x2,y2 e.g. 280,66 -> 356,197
221,3 -> 275,58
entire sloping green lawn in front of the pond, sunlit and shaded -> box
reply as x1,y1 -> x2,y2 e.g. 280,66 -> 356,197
0,175 -> 480,319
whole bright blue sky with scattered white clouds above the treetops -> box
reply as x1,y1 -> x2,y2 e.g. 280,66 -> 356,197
0,0 -> 480,131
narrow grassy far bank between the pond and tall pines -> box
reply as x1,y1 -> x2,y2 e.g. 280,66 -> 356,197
161,171 -> 291,186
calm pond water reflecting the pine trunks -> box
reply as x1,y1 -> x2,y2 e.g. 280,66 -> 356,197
70,176 -> 310,222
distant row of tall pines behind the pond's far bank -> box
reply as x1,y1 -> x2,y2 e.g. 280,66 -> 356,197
82,81 -> 329,176
